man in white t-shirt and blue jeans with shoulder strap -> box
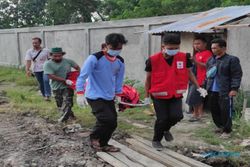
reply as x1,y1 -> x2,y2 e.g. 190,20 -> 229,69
25,37 -> 51,101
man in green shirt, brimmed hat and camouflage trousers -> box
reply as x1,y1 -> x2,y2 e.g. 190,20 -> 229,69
43,48 -> 80,122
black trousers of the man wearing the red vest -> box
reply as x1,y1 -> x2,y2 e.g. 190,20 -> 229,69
153,98 -> 183,141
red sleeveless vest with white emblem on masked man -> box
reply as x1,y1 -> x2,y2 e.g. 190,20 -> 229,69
149,52 -> 188,99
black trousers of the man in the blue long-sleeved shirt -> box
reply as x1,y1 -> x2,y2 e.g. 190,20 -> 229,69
87,99 -> 117,146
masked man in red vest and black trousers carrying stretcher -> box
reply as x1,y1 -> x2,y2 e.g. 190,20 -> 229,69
144,33 -> 207,150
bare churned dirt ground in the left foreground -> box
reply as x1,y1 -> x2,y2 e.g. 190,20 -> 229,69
0,109 -> 109,167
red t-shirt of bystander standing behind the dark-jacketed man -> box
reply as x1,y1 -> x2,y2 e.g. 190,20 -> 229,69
195,50 -> 212,86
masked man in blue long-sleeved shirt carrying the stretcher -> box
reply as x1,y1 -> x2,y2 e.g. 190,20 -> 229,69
76,33 -> 127,152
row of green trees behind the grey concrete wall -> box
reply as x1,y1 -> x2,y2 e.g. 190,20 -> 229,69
0,0 -> 250,29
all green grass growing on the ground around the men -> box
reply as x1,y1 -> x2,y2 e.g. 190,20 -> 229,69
0,67 -> 250,156
